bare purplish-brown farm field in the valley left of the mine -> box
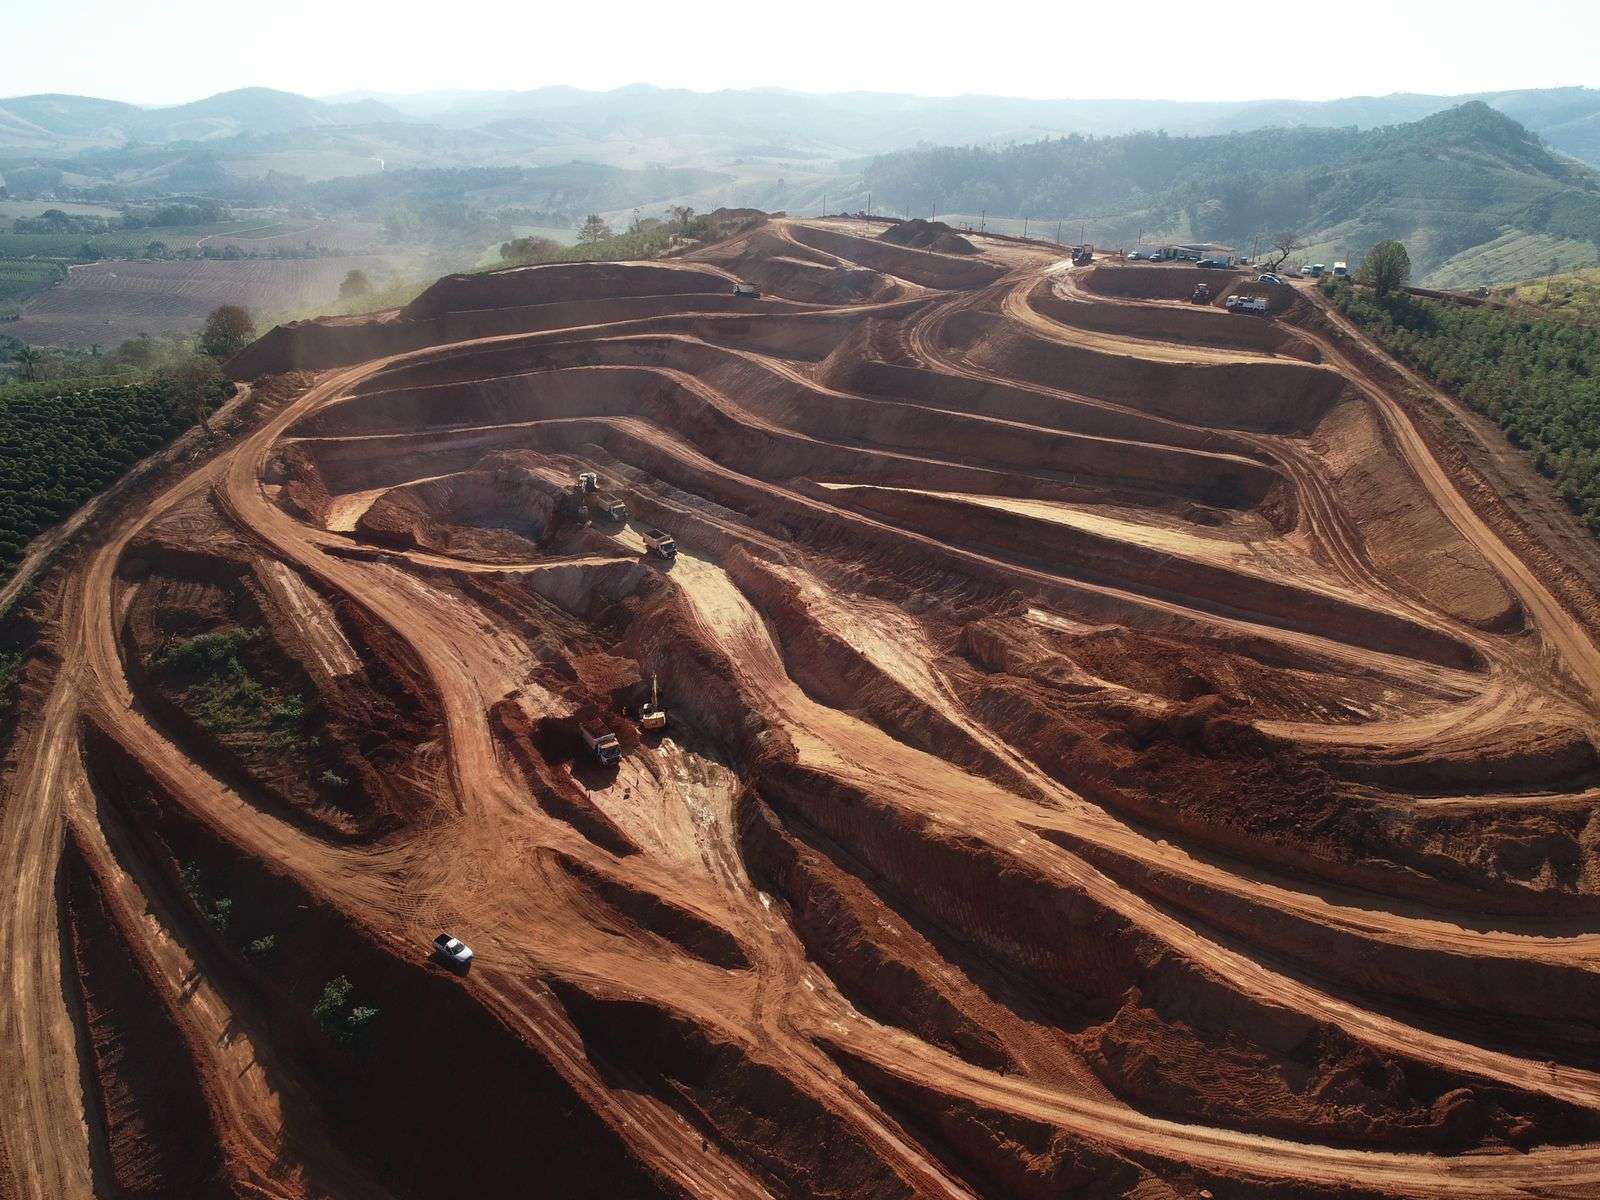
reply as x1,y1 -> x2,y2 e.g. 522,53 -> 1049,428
3,254 -> 406,346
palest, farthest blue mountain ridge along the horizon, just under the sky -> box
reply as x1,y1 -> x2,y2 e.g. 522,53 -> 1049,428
0,85 -> 1600,173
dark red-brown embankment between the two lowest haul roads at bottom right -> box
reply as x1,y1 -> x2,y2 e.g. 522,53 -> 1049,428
762,768 -> 1600,1149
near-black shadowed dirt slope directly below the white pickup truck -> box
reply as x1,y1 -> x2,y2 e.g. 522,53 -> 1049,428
90,723 -> 669,1197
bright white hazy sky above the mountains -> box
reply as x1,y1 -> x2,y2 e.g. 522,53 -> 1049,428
12,0 -> 1600,104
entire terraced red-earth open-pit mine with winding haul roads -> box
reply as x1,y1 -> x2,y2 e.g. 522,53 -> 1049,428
9,219 -> 1600,1200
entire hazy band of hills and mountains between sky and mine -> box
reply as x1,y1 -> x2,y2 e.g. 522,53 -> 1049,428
0,85 -> 1600,283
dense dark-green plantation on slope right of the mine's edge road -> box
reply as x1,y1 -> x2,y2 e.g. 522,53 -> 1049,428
1322,278 -> 1600,536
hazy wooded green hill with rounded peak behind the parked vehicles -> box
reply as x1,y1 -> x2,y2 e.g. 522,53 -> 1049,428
866,101 -> 1600,286
